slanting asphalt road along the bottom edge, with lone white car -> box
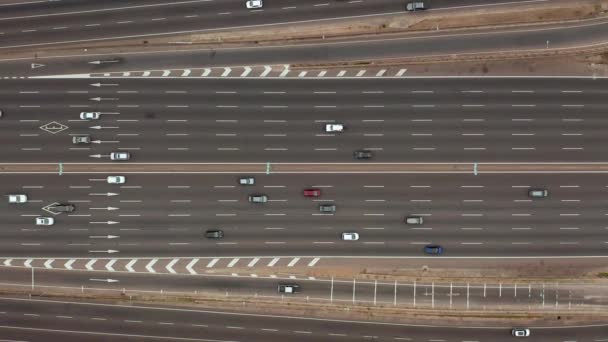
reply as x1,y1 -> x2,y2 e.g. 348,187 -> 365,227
0,298 -> 607,342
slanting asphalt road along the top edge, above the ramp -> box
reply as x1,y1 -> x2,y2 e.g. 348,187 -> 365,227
0,0 -> 540,48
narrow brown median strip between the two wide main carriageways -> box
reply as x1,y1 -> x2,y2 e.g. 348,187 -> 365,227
0,163 -> 608,175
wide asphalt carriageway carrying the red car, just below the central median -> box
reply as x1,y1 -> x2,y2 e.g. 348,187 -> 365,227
0,174 -> 608,258
